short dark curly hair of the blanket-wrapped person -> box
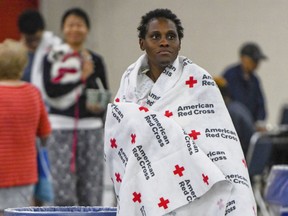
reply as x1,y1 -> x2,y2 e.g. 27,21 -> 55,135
137,9 -> 184,40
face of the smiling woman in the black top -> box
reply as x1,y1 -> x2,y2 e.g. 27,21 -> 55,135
62,14 -> 89,46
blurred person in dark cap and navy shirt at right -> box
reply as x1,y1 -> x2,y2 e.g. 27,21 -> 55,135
223,43 -> 267,130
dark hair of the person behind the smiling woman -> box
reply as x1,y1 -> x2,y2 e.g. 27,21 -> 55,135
18,9 -> 45,35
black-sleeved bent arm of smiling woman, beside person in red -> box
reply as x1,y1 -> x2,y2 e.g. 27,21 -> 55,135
43,56 -> 82,98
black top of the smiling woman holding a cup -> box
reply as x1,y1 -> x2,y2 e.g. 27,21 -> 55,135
43,51 -> 108,118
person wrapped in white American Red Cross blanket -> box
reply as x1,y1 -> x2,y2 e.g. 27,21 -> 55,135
105,9 -> 257,216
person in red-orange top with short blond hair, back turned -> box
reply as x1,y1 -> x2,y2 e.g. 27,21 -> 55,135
0,40 -> 51,215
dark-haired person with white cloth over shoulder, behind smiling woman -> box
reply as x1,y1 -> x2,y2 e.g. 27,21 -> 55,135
18,9 -> 61,99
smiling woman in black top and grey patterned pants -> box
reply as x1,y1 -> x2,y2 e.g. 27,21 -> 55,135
44,8 -> 107,206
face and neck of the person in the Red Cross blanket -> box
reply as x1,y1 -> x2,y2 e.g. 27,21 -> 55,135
139,18 -> 181,82
